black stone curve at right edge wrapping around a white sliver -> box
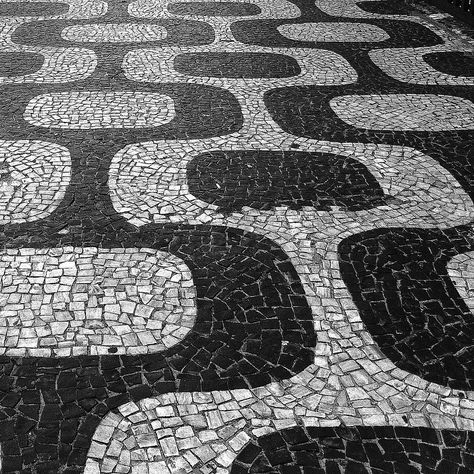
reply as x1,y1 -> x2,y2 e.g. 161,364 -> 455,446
338,226 -> 474,390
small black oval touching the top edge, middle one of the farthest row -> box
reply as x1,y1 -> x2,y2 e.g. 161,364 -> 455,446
168,2 -> 262,16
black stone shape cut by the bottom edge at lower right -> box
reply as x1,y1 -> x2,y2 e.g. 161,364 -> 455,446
230,426 -> 474,474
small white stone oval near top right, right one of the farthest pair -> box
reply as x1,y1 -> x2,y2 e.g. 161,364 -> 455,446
277,22 -> 390,43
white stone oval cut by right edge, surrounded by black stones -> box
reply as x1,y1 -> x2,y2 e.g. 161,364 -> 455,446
330,94 -> 474,132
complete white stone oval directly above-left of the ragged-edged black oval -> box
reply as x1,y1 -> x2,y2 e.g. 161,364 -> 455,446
24,91 -> 175,130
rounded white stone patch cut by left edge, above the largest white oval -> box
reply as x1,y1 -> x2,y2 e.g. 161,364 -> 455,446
0,140 -> 71,225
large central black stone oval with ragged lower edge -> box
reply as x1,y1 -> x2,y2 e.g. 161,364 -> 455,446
187,150 -> 387,212
